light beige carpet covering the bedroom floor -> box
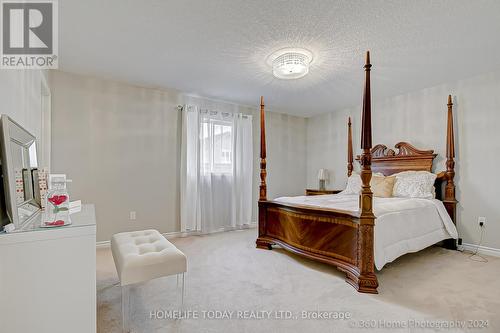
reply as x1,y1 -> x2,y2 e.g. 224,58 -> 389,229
97,229 -> 500,333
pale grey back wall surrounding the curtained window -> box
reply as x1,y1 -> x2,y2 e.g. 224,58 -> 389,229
50,71 -> 306,241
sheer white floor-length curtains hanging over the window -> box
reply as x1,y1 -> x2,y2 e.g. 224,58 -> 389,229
181,105 -> 253,233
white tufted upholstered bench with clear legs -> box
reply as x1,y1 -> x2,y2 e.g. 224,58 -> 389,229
111,230 -> 187,332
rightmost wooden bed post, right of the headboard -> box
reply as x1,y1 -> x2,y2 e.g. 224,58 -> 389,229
443,95 -> 457,250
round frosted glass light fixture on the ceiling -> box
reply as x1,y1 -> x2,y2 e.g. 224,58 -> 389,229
267,48 -> 313,80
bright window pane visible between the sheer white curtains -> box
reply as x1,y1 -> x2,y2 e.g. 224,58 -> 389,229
200,118 -> 233,173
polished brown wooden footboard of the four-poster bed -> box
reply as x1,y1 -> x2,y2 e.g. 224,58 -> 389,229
256,201 -> 378,293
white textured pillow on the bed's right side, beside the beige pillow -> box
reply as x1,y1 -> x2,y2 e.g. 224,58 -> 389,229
392,171 -> 437,199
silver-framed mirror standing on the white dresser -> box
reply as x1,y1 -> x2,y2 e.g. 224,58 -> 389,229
1,115 -> 40,228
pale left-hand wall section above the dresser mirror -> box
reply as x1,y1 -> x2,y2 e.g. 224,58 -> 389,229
0,70 -> 50,165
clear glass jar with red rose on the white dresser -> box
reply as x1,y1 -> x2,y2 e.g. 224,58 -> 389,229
43,174 -> 70,226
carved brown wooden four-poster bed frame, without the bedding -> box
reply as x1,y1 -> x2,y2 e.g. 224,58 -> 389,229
256,52 -> 457,293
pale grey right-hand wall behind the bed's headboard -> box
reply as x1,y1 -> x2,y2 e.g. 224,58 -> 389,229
307,68 -> 500,248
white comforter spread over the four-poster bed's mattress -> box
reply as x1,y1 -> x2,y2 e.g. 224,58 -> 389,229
274,193 -> 458,270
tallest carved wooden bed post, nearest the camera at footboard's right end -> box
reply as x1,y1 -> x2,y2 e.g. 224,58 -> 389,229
347,51 -> 378,294
